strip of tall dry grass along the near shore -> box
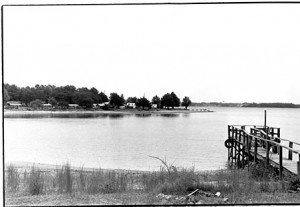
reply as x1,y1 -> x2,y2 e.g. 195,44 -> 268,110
5,160 -> 300,204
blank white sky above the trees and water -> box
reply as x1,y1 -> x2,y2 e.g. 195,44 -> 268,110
3,4 -> 300,104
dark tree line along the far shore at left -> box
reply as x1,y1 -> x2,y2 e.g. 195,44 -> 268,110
3,84 -> 191,109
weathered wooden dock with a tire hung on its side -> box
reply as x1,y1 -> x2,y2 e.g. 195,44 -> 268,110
225,125 -> 300,178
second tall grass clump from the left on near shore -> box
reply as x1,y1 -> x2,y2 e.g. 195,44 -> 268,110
25,166 -> 44,195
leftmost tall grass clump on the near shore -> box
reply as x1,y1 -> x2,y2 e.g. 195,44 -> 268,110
6,164 -> 20,192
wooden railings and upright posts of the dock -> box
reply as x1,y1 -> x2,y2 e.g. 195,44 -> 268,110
225,125 -> 300,178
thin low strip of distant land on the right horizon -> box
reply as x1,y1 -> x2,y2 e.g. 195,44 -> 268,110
191,102 -> 300,108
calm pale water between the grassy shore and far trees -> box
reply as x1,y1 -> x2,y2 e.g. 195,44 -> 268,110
4,107 -> 300,170
